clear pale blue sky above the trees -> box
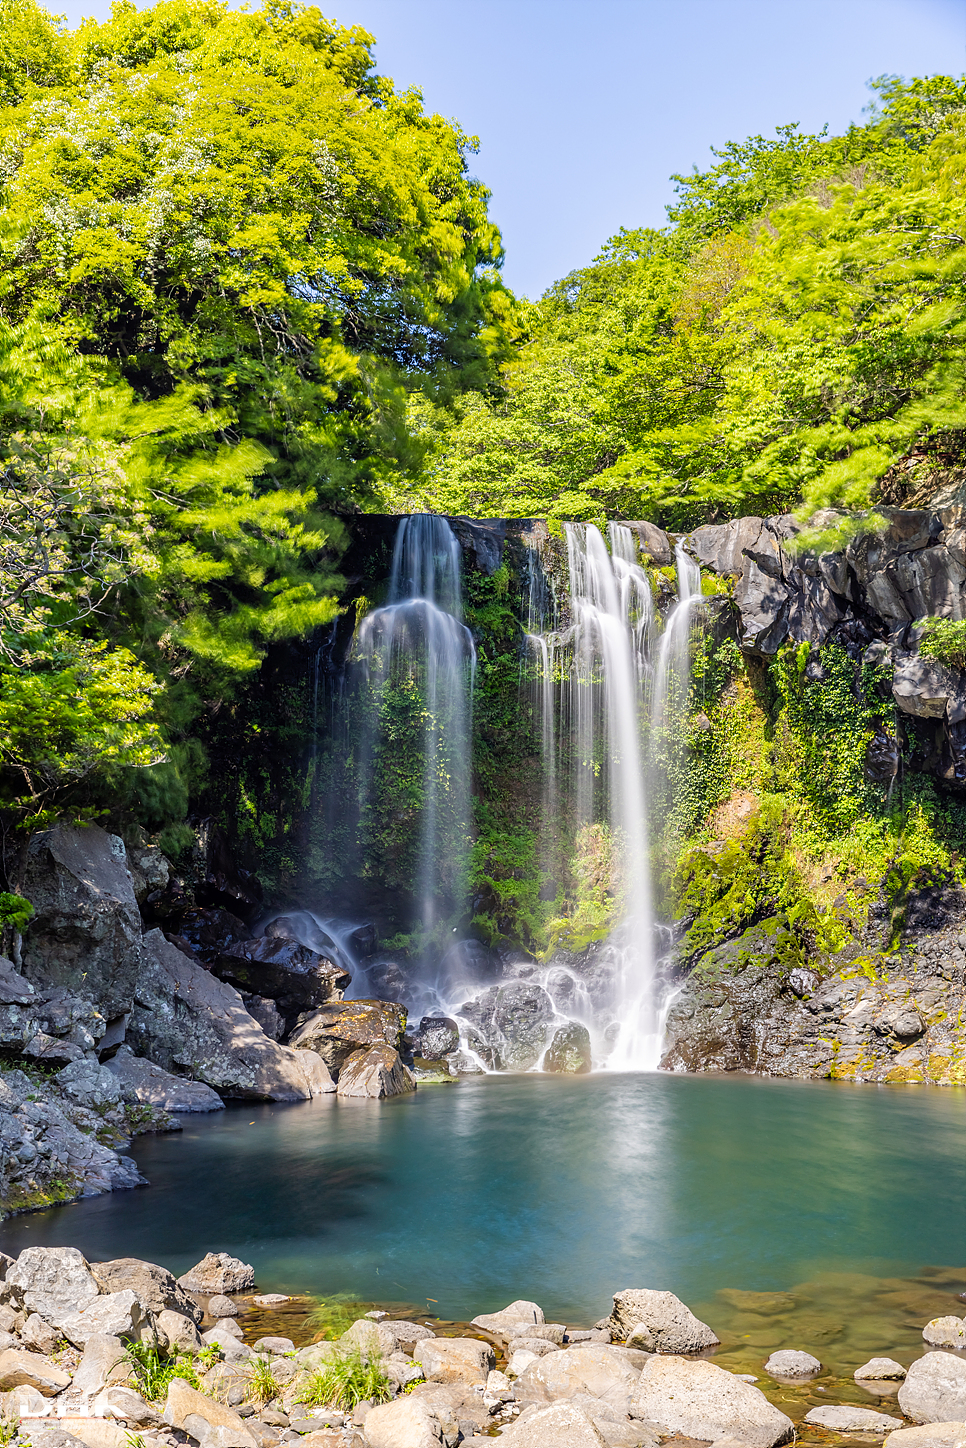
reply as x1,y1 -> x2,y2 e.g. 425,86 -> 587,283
58,0 -> 966,297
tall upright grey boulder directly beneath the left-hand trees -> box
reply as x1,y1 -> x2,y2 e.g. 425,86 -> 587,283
20,824 -> 142,1019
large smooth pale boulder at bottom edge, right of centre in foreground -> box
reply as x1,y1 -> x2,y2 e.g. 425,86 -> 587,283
634,1357 -> 795,1448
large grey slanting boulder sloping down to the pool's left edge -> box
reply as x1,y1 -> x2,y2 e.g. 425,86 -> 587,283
127,930 -> 327,1100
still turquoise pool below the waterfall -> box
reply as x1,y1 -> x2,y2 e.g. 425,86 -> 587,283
0,1074 -> 966,1326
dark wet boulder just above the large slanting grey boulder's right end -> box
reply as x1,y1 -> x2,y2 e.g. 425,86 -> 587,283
211,935 -> 352,1015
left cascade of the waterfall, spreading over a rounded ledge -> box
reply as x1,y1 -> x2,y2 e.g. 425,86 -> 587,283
353,514 -> 476,935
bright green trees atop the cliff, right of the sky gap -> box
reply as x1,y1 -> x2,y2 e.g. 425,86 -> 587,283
402,77 -> 966,527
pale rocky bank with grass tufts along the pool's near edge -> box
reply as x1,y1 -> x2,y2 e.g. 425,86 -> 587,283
0,1247 -> 966,1448
